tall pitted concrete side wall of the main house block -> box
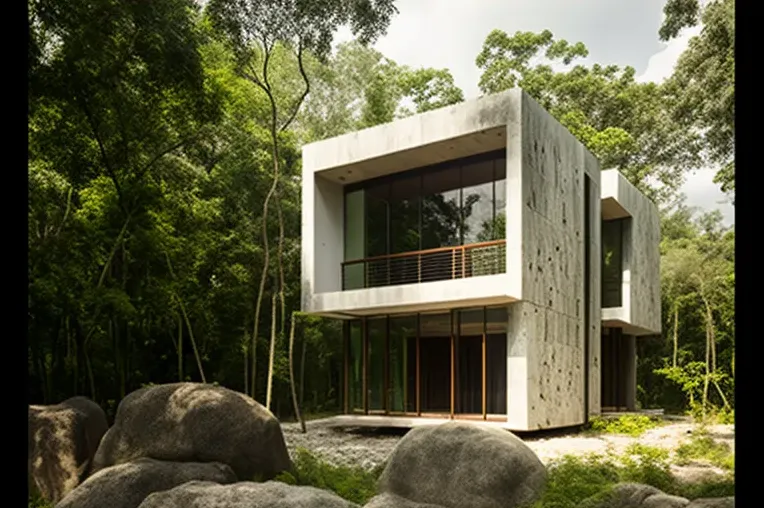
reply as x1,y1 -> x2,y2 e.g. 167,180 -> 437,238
507,94 -> 601,430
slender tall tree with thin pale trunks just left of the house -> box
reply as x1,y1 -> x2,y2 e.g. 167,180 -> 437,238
208,0 -> 396,412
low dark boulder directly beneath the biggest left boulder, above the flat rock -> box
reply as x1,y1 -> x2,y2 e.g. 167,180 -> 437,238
56,458 -> 236,508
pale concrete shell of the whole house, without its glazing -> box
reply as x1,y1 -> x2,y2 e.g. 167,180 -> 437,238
302,89 -> 660,431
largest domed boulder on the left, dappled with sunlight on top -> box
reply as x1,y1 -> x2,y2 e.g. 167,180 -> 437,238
90,383 -> 291,480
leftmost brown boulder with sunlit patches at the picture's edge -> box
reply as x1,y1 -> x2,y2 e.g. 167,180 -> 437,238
27,397 -> 109,503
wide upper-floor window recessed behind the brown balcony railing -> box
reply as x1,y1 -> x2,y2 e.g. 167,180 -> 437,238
343,150 -> 506,289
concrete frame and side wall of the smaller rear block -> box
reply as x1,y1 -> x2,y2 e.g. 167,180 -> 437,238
602,169 -> 661,335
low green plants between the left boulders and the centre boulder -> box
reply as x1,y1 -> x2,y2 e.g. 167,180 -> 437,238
276,448 -> 382,505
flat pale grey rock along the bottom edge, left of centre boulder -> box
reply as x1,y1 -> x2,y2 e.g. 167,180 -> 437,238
140,481 -> 359,508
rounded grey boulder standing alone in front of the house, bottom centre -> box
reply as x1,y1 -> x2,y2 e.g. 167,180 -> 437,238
375,422 -> 546,508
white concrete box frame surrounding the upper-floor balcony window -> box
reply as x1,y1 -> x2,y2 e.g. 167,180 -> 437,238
302,90 -> 522,315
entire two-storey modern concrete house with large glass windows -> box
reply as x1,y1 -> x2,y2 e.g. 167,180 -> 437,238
302,89 -> 661,431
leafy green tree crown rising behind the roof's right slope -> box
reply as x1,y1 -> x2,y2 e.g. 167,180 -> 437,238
476,30 -> 699,202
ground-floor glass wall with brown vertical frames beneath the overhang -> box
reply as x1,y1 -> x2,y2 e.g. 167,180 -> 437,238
345,307 -> 508,418
